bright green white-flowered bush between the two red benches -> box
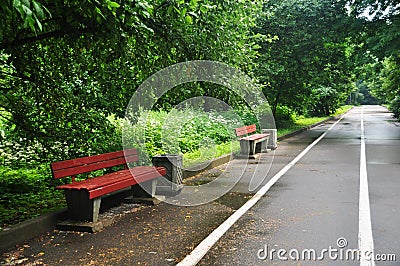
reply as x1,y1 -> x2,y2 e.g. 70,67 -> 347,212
119,110 -> 255,160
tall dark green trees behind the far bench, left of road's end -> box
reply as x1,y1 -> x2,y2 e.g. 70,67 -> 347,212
257,0 -> 356,115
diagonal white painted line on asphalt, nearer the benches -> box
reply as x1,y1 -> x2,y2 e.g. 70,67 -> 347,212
177,114 -> 347,266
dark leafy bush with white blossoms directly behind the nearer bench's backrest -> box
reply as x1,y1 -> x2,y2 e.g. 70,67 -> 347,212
0,110 -> 122,169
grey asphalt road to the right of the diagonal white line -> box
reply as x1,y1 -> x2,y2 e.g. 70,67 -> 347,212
191,106 -> 400,265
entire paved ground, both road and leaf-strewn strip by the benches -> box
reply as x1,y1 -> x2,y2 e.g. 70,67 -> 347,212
2,106 -> 400,265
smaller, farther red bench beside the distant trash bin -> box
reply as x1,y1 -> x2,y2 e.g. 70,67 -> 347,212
235,124 -> 270,155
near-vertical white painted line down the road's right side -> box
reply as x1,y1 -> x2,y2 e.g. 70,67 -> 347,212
358,107 -> 375,266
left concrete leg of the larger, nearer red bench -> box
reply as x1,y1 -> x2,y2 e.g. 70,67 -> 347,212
64,190 -> 101,222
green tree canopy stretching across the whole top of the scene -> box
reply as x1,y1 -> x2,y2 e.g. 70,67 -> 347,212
0,0 -> 399,162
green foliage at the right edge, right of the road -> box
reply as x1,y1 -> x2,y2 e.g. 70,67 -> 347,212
352,0 -> 400,116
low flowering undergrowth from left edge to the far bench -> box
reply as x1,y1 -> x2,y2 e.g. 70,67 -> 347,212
0,110 -> 257,226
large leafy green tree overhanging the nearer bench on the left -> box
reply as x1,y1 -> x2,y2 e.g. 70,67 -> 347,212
0,0 -> 259,160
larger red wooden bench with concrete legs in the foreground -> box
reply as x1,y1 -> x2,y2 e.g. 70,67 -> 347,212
51,149 -> 166,222
